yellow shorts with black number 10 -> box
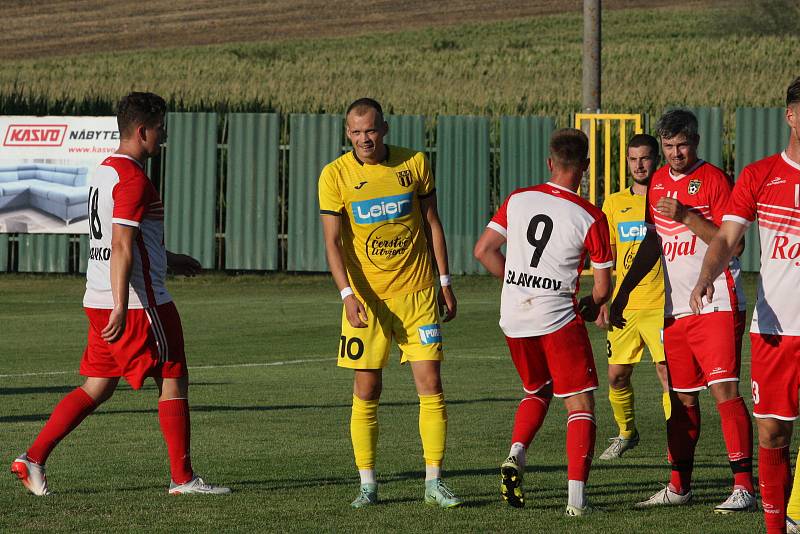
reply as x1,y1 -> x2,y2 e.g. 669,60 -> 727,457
338,287 -> 444,369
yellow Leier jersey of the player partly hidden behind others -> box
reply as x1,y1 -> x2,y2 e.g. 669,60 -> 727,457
603,188 -> 664,310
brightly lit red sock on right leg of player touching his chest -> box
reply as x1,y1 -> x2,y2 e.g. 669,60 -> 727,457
717,397 -> 755,494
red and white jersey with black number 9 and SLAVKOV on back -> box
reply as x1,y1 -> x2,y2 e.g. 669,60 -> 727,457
488,183 -> 613,337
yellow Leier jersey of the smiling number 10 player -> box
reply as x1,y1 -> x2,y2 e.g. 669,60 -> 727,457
319,145 -> 434,299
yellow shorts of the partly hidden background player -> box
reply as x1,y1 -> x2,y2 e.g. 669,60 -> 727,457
606,308 -> 665,365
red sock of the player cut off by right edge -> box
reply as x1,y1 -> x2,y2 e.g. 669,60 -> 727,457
758,446 -> 792,534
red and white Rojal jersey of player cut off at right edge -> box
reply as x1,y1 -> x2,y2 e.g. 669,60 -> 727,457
715,152 -> 800,336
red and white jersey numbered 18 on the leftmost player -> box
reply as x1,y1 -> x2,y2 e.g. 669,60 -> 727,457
83,154 -> 172,309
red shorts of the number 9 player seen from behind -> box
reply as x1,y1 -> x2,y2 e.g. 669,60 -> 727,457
506,317 -> 597,397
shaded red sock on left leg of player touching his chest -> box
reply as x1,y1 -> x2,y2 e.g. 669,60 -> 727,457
667,402 -> 700,493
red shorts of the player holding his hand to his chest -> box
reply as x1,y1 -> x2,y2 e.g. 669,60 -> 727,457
664,311 -> 744,392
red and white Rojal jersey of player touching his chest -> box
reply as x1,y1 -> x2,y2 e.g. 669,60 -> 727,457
645,160 -> 744,317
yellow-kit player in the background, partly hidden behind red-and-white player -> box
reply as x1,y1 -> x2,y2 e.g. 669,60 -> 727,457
597,134 -> 669,460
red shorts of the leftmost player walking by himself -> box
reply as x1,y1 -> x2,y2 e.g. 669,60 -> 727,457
80,302 -> 188,389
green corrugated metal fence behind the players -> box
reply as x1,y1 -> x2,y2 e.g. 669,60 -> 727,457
0,108 -> 788,273
